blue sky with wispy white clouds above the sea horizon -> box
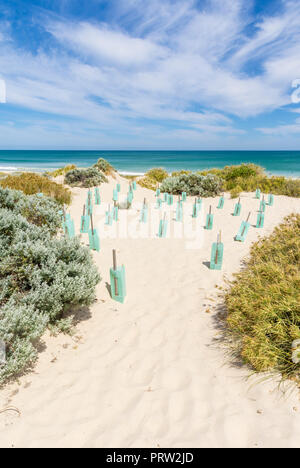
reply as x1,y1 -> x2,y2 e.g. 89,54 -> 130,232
0,0 -> 300,150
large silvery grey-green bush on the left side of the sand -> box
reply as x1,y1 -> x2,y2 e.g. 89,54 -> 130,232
0,188 -> 100,384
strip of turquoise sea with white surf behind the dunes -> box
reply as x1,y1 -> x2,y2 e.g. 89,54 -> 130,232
0,150 -> 300,177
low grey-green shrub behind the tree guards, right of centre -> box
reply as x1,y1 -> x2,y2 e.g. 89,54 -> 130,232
161,173 -> 222,197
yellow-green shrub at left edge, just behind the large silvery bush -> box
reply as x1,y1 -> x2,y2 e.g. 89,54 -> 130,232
0,172 -> 72,205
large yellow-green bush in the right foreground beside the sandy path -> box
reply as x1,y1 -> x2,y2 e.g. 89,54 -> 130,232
226,215 -> 300,380
